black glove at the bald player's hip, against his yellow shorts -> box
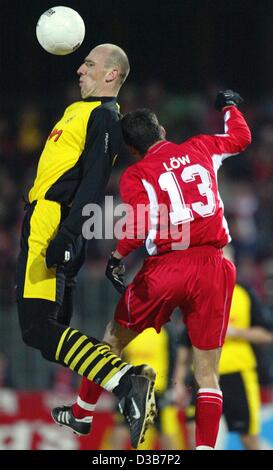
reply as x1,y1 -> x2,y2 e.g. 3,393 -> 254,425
46,232 -> 73,268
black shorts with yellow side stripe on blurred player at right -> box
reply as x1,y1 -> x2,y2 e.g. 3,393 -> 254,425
185,369 -> 261,435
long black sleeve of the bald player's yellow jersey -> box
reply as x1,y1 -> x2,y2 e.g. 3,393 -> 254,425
60,108 -> 121,238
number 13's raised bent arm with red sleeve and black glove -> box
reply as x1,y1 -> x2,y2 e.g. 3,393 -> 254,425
194,90 -> 251,161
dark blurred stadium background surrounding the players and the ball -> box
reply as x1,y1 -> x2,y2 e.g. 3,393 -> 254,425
0,0 -> 273,449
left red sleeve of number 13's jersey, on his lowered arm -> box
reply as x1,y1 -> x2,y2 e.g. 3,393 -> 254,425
116,165 -> 149,256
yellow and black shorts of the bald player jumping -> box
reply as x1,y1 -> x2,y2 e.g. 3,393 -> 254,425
16,199 -> 82,304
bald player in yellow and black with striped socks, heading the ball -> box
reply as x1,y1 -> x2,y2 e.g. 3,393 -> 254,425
16,44 -> 154,447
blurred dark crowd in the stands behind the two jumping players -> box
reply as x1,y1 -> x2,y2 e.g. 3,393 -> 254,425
0,81 -> 273,390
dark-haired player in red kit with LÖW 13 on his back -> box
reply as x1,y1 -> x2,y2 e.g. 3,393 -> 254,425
54,90 -> 251,449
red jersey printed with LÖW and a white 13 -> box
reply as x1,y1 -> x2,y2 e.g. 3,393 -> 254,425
117,106 -> 251,256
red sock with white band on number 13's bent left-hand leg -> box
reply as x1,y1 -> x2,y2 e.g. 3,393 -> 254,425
72,377 -> 103,419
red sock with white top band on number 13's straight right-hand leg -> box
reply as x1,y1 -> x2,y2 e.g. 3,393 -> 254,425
195,388 -> 223,448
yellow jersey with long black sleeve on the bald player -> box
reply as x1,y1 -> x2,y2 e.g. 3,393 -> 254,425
29,97 -> 121,241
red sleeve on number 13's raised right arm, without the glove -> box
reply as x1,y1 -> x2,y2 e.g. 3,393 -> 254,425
193,106 -> 251,164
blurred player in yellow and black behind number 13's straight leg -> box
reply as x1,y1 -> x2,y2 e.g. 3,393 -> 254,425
173,274 -> 273,450
